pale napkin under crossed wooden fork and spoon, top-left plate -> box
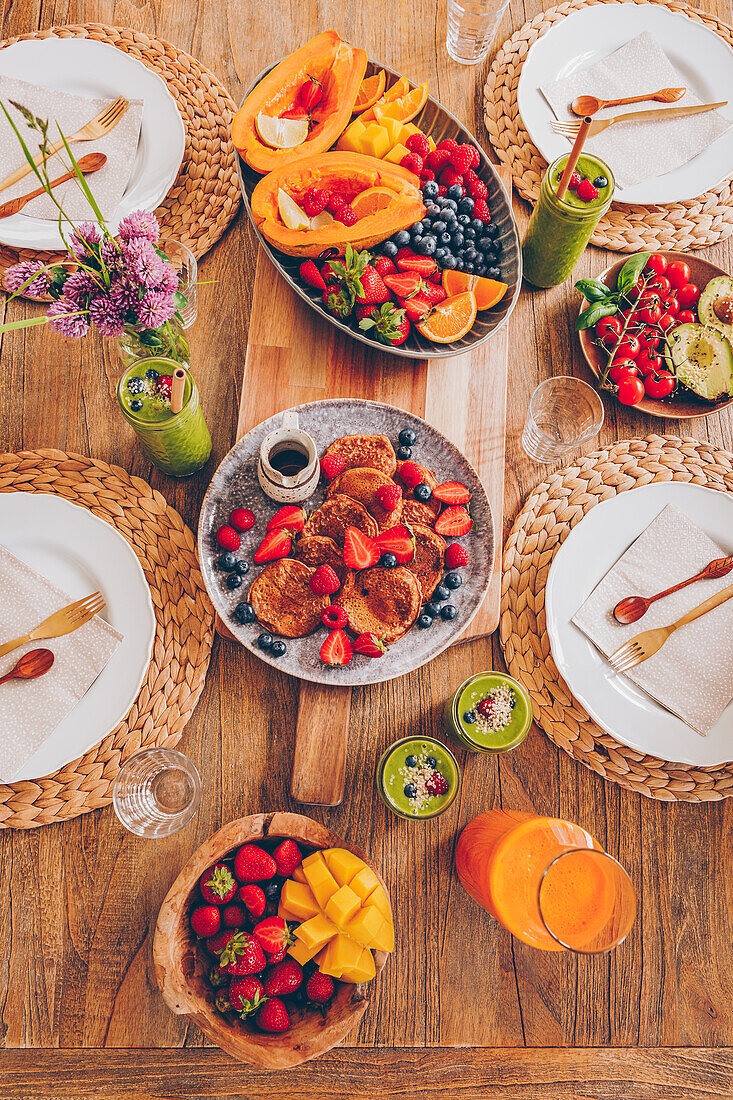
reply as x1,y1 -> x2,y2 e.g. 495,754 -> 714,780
0,76 -> 143,221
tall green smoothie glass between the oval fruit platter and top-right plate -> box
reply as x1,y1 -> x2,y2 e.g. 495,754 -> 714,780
522,153 -> 614,287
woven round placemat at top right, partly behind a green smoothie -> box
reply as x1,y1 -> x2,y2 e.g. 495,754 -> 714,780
483,0 -> 733,252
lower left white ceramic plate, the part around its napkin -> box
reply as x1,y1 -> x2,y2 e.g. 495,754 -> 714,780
0,493 -> 155,781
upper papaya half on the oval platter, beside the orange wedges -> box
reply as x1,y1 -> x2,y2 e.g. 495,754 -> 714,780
231,31 -> 367,173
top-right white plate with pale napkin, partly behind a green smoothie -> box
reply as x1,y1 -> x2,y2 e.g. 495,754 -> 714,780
517,3 -> 733,205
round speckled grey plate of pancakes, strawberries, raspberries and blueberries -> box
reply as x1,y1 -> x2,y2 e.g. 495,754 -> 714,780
198,398 -> 494,686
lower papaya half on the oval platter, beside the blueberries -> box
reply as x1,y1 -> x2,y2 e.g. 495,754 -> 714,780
251,151 -> 425,256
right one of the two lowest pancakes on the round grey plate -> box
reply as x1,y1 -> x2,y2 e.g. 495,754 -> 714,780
336,565 -> 422,645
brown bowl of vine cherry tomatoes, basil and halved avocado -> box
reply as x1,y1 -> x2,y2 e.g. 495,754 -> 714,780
576,252 -> 733,420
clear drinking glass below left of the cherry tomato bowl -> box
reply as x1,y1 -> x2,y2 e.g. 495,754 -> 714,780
522,376 -> 603,462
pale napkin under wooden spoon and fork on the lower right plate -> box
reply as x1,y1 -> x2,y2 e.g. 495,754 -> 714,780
572,504 -> 733,737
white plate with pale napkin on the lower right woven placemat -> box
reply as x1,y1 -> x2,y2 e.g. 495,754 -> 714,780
545,482 -> 733,767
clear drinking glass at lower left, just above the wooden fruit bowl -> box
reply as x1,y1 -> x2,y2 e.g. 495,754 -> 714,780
112,748 -> 201,839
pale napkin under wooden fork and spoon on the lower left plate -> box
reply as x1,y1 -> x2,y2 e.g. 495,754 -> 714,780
0,546 -> 122,782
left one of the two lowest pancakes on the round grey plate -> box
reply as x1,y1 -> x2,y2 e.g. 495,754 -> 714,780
250,558 -> 331,638
